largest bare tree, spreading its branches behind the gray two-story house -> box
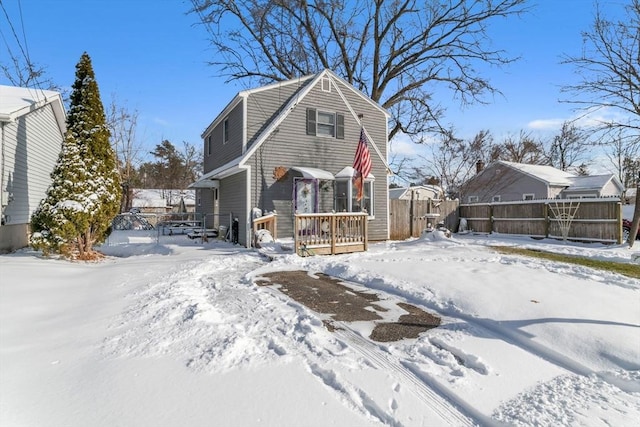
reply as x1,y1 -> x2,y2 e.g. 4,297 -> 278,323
191,0 -> 527,142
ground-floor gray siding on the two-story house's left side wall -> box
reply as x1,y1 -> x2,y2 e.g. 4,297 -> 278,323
220,172 -> 251,246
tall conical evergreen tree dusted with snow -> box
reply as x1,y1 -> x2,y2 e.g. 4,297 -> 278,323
31,52 -> 121,259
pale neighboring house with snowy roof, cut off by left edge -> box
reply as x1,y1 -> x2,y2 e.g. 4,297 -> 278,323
0,85 -> 66,253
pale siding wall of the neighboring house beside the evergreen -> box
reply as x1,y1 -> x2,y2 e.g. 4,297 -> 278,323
0,104 -> 63,224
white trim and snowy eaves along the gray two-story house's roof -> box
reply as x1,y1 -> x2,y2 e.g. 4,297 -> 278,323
189,70 -> 390,188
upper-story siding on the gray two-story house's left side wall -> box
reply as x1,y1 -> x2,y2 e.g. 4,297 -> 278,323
203,102 -> 243,173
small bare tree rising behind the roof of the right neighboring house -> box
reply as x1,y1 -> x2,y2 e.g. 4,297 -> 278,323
547,122 -> 588,171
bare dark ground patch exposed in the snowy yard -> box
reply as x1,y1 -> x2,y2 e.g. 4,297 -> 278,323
256,271 -> 440,342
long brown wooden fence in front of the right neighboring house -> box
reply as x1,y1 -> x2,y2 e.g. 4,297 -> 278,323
459,198 -> 622,243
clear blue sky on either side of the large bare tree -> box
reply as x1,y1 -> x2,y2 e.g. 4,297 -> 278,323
0,0 -> 625,164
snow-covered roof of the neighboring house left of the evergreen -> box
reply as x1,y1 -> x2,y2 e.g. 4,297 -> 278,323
0,85 -> 66,134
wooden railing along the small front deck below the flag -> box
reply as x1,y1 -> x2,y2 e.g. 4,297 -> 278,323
294,212 -> 368,256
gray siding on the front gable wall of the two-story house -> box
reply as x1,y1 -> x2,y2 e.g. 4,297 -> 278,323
247,78 -> 388,241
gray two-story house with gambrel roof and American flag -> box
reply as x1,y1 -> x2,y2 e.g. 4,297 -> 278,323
191,70 -> 389,246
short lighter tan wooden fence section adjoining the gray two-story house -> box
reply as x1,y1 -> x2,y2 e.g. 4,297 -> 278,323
389,199 -> 458,240
